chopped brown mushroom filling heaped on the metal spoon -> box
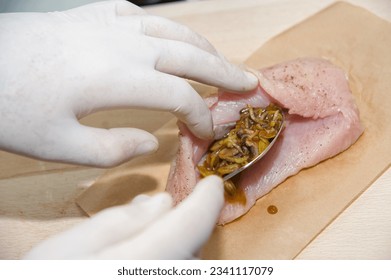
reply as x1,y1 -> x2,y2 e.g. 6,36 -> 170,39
197,103 -> 283,196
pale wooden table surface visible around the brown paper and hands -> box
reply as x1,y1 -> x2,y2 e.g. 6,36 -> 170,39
0,0 -> 391,259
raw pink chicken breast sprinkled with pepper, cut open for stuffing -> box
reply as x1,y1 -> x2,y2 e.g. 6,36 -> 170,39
166,58 -> 363,224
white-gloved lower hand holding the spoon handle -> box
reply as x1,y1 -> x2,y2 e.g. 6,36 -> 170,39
25,176 -> 224,259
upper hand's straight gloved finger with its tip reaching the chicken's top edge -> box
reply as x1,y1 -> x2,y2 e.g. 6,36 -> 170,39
156,40 -> 258,92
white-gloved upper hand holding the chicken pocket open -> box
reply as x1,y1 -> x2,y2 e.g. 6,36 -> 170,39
0,1 -> 258,167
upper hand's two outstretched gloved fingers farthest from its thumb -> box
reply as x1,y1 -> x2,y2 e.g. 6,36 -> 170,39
133,16 -> 258,92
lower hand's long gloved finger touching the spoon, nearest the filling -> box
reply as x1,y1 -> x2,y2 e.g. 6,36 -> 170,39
93,176 -> 224,259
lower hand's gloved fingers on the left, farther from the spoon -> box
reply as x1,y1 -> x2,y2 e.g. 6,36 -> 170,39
25,193 -> 172,259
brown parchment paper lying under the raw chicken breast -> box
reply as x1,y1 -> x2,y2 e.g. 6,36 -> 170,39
77,3 -> 391,259
